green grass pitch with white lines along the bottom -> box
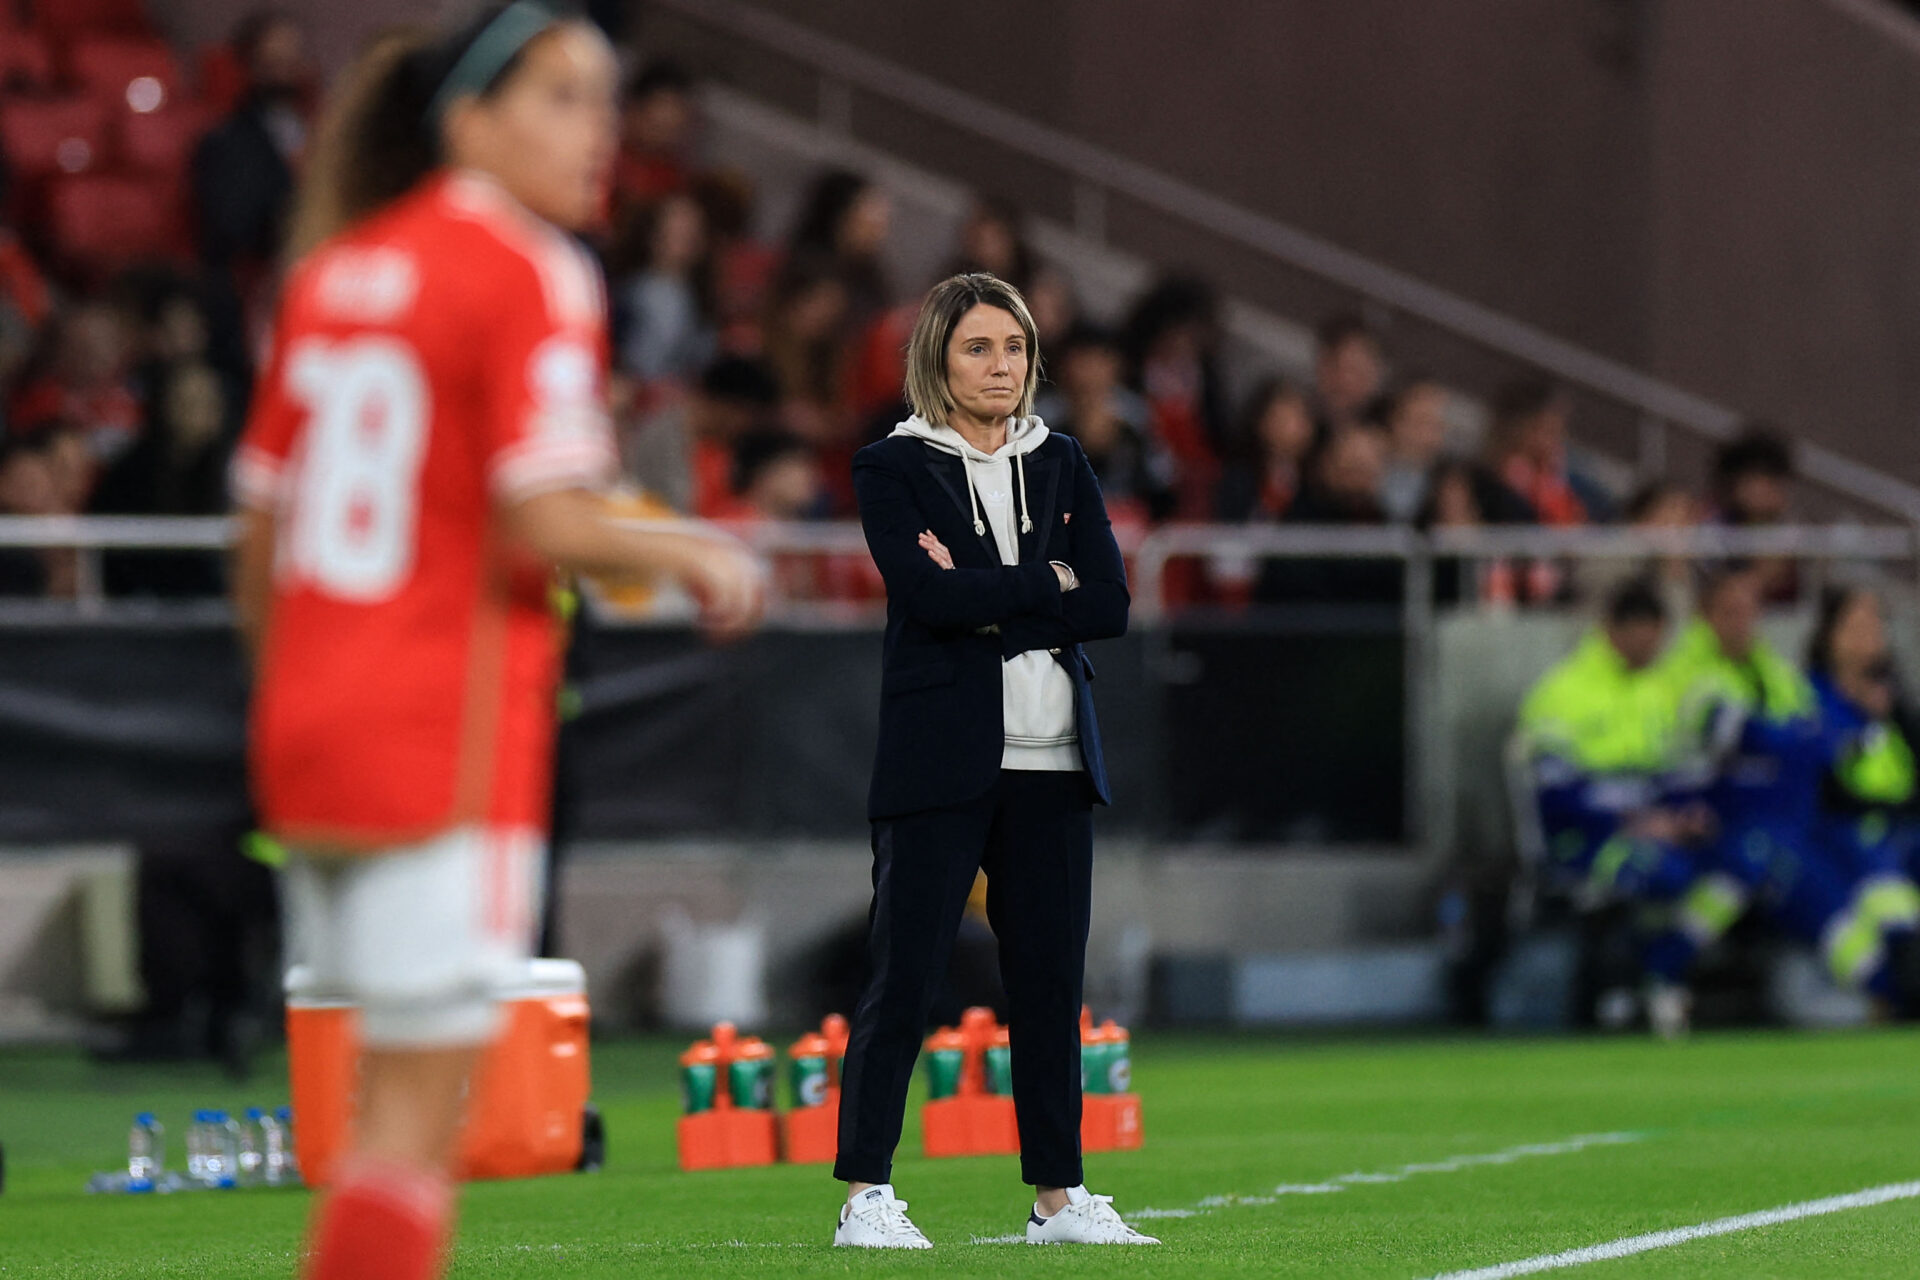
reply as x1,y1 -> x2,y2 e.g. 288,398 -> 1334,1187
0,1031 -> 1920,1280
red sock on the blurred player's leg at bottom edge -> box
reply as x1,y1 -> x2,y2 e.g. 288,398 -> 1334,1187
305,1157 -> 453,1280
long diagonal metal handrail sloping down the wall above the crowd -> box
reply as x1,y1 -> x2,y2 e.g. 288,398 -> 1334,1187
655,0 -> 1920,524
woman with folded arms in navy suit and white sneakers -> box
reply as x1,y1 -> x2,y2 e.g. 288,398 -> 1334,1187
833,274 -> 1158,1249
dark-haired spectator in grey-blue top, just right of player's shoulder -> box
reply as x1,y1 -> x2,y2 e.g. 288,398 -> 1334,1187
609,192 -> 716,384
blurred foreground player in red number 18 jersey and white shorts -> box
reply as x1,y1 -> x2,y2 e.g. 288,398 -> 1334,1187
234,0 -> 760,1280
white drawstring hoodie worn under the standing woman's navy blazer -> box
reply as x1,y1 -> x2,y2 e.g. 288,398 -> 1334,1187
893,415 -> 1087,773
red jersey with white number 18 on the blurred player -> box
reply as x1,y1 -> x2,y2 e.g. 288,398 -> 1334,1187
234,173 -> 616,848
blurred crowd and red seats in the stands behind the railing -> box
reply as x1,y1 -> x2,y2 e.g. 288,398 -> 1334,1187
0,0 -> 1795,604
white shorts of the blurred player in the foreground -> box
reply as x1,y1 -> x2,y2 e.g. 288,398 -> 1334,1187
286,827 -> 543,1048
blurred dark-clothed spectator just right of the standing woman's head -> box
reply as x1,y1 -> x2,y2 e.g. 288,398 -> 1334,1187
1035,324 -> 1175,526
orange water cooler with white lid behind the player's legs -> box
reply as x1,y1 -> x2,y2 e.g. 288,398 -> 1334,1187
286,960 -> 599,1186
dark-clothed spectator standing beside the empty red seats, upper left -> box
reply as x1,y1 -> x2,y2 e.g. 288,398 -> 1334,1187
190,10 -> 313,314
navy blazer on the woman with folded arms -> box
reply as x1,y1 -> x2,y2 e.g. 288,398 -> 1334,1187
852,434 -> 1129,821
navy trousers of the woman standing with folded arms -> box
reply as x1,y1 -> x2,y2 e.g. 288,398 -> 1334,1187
833,770 -> 1092,1186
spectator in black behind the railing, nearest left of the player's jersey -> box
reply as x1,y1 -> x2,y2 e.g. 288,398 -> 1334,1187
92,363 -> 232,597
